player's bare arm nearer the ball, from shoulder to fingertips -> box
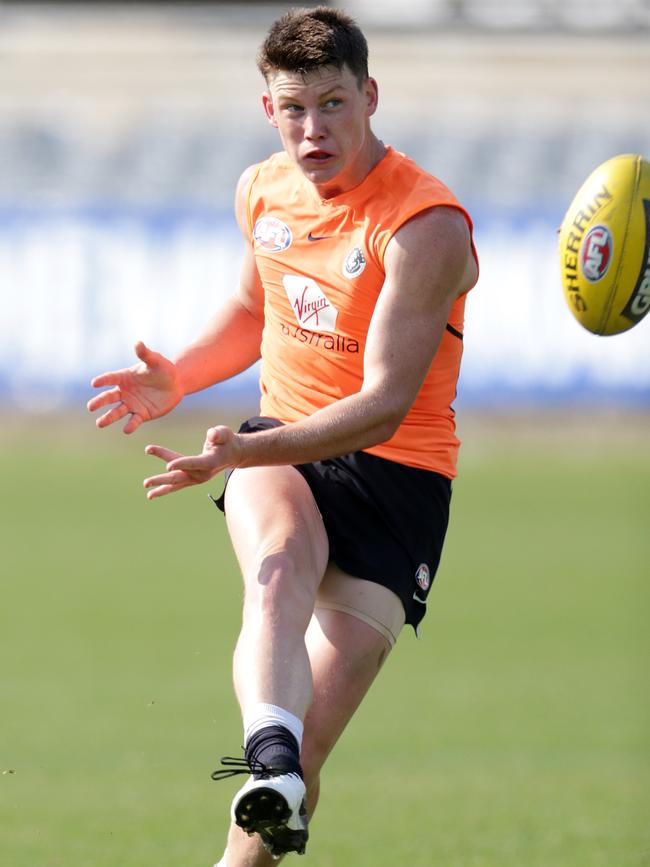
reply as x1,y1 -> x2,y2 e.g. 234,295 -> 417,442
145,207 -> 476,497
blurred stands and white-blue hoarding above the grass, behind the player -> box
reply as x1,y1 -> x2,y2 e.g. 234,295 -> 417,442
0,0 -> 650,409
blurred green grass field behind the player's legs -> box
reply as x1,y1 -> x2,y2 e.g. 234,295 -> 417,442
0,415 -> 650,867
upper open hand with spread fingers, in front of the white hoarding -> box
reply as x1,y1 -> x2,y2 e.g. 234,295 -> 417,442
87,341 -> 185,434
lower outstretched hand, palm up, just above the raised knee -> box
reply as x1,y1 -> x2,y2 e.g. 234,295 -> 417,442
143,425 -> 239,500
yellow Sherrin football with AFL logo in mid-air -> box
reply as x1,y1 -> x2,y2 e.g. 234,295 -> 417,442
560,154 -> 650,334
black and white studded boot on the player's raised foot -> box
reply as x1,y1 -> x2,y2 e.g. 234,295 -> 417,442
212,756 -> 309,858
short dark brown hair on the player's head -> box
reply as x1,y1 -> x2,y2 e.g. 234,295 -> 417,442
257,6 -> 368,85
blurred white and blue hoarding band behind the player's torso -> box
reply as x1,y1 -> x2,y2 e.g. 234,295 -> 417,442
0,213 -> 650,408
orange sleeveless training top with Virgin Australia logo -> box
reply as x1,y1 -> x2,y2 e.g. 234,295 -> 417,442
248,148 -> 476,478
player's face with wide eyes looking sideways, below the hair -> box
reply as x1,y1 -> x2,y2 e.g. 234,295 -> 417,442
262,66 -> 377,197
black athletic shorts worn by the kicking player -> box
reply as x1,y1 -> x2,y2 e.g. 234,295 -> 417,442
215,416 -> 451,628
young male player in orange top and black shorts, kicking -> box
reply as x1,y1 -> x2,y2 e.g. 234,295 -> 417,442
88,7 -> 477,867
